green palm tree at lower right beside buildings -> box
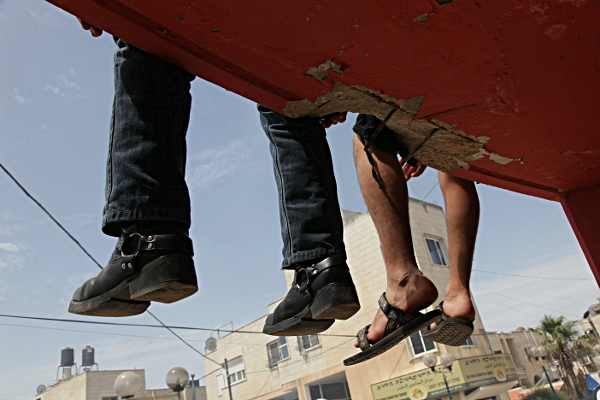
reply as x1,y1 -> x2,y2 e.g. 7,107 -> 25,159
535,315 -> 585,398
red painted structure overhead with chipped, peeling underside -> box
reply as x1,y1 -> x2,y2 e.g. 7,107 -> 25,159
48,0 -> 600,282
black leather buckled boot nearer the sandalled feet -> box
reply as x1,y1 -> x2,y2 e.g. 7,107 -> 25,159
263,256 -> 360,336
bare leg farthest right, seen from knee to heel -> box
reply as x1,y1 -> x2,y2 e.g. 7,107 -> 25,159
438,172 -> 479,320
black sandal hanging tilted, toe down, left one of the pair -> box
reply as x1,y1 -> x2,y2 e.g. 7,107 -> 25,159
344,293 -> 442,366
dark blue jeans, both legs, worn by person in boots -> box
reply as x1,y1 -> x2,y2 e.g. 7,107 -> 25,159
102,39 -> 345,268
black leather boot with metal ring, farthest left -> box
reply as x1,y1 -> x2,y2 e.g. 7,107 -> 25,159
69,233 -> 198,317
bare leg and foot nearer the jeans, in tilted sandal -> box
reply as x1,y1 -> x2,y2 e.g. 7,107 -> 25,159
354,136 -> 438,342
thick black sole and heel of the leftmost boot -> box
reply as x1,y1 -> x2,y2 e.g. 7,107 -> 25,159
69,254 -> 198,317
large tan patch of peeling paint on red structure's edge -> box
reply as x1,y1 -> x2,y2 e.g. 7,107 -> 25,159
282,82 -> 513,172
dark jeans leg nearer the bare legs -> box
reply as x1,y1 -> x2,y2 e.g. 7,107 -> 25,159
258,106 -> 346,268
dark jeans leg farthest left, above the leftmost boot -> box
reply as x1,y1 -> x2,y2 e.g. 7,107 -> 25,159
102,39 -> 194,236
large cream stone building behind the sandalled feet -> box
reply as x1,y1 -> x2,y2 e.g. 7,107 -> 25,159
204,199 -> 519,400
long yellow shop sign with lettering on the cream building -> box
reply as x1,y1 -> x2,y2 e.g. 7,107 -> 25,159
371,354 -> 517,400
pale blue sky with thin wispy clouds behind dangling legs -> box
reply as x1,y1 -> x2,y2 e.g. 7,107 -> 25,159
0,0 -> 599,400
